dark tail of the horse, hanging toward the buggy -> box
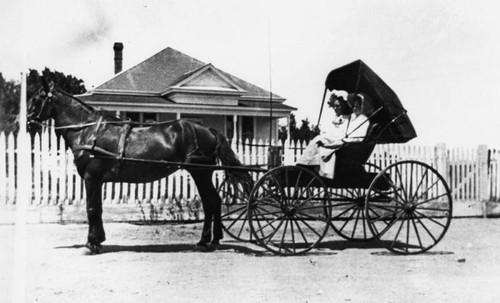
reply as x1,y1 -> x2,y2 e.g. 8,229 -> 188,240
210,128 -> 254,194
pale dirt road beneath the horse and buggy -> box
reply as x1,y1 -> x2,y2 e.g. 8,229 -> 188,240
0,219 -> 500,302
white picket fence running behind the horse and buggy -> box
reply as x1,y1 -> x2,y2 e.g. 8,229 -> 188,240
0,130 -> 500,206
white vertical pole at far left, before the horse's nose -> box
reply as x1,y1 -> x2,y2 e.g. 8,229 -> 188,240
12,72 -> 31,302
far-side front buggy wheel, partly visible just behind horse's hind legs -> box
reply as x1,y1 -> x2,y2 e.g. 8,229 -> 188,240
218,178 -> 252,242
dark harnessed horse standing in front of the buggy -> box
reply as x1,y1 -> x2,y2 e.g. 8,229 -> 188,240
28,78 -> 251,253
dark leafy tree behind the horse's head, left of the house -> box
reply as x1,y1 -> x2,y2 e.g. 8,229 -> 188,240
0,67 -> 87,132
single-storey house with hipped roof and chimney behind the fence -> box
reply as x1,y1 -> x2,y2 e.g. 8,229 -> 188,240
79,43 -> 296,140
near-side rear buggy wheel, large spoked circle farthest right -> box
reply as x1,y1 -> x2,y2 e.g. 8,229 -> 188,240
366,161 -> 453,254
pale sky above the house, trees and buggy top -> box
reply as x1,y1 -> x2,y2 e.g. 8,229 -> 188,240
0,0 -> 500,148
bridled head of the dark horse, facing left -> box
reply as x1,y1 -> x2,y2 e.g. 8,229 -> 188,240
27,77 -> 54,122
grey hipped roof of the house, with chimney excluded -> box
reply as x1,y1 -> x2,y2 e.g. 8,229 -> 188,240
94,47 -> 285,101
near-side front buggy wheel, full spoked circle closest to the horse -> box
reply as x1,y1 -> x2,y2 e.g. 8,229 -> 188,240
248,166 -> 331,256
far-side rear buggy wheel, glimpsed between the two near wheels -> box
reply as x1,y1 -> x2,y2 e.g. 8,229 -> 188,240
330,163 -> 382,242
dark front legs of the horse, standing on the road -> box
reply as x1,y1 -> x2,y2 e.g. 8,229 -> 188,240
85,179 -> 106,254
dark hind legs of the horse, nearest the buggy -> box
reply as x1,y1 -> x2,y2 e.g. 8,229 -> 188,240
191,170 -> 222,249
